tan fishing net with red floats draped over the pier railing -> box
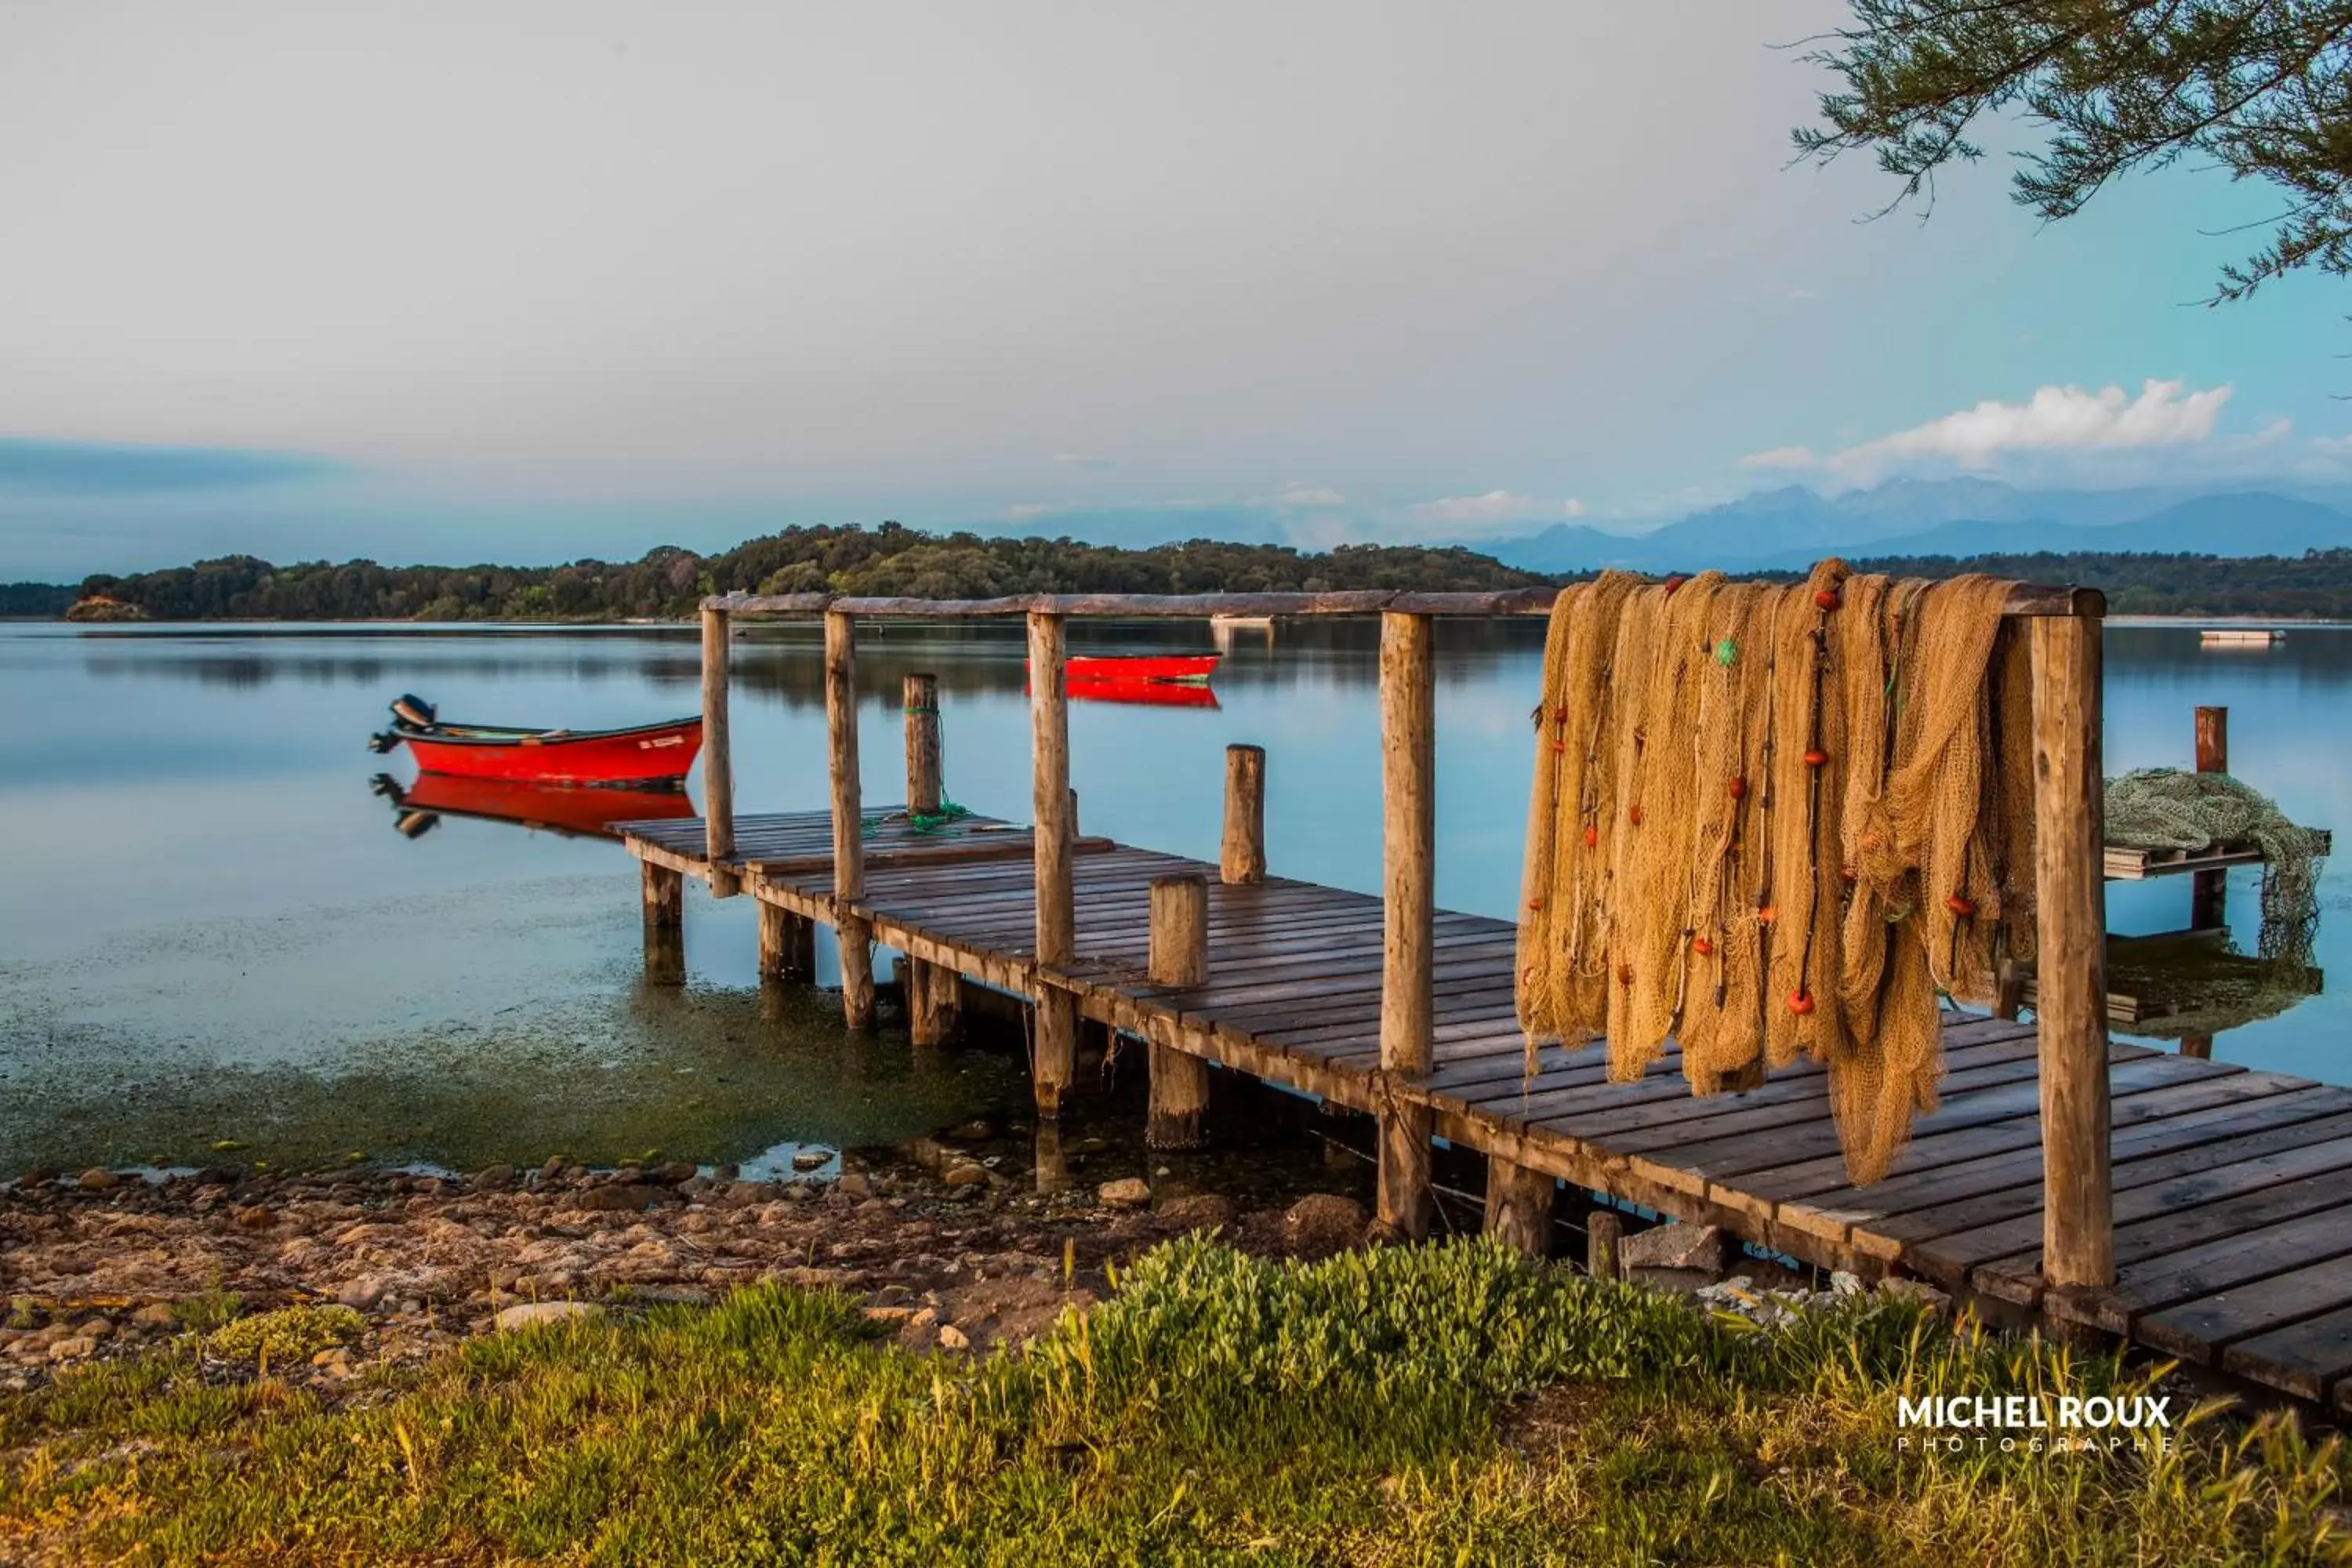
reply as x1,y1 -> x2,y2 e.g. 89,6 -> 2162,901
1519,560 -> 2032,1182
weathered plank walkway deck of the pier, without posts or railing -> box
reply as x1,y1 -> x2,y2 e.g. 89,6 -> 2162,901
621,811 -> 2352,1410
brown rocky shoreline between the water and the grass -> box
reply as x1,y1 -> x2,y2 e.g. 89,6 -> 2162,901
0,1128 -> 1364,1392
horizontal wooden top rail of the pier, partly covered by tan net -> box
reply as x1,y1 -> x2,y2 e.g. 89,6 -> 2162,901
703,583 -> 2107,621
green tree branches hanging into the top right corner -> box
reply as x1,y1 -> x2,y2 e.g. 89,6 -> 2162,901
1795,0 -> 2352,303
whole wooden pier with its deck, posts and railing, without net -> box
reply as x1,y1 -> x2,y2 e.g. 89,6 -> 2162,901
623,590 -> 2352,1410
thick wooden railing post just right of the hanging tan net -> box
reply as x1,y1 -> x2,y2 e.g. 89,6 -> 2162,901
2032,616 -> 2114,1288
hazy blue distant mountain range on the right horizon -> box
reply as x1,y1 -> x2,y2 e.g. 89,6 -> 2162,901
1472,480 -> 2352,572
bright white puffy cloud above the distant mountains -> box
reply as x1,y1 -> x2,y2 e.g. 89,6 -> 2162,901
1740,381 -> 2232,485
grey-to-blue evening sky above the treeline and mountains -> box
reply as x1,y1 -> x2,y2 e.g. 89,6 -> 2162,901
0,0 -> 2352,581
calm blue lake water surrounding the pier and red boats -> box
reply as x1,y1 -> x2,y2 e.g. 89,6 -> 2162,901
0,623 -> 2352,1171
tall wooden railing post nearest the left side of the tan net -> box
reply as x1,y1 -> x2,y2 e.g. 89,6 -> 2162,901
1378,612 -> 1437,1241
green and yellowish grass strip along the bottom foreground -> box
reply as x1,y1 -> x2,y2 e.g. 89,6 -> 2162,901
0,1241 -> 2347,1566
